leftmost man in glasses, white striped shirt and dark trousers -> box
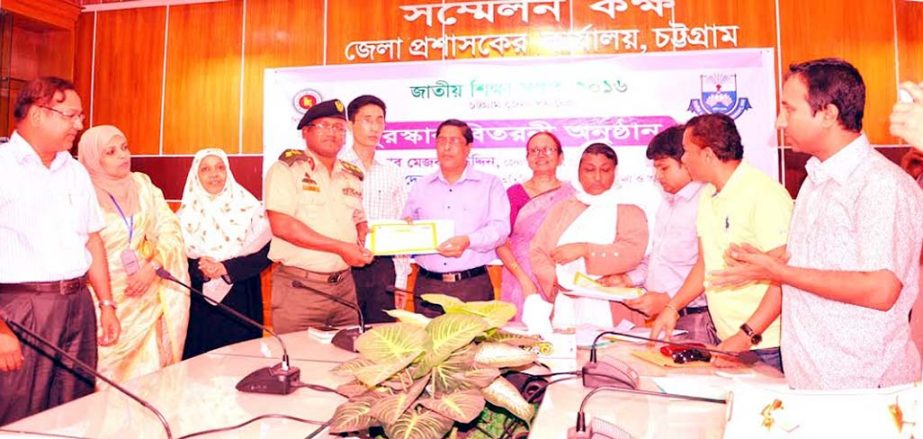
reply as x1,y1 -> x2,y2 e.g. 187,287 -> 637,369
0,77 -> 120,425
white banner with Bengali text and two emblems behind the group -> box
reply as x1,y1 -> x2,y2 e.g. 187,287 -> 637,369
263,49 -> 779,219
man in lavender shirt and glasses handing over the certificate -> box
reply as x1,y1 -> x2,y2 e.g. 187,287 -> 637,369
403,119 -> 510,317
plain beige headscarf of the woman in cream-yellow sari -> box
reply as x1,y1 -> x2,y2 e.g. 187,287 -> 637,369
77,125 -> 140,216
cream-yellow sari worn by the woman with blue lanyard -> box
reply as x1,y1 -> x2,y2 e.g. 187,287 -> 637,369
93,172 -> 189,382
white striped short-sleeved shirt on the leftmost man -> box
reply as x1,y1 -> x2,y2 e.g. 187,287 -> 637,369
0,132 -> 104,283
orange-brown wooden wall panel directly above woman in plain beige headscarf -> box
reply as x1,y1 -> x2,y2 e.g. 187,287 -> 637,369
93,7 -> 167,154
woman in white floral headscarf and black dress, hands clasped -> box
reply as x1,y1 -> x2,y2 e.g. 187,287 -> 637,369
177,148 -> 271,358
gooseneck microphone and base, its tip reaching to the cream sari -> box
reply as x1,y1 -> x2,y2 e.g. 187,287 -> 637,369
157,267 -> 302,395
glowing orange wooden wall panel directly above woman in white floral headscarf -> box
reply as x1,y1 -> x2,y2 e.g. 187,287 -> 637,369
163,0 -> 244,154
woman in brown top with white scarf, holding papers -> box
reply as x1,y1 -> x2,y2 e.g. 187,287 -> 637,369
523,143 -> 648,334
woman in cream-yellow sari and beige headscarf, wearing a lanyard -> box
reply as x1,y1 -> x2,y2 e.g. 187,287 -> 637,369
77,125 -> 189,382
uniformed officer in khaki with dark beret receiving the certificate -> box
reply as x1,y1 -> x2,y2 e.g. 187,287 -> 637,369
264,99 -> 372,333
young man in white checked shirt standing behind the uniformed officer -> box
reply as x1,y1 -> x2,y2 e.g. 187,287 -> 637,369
340,95 -> 410,323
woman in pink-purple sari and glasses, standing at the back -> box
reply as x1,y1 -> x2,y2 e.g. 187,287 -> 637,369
497,131 -> 574,320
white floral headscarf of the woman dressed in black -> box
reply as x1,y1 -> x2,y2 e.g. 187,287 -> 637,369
177,148 -> 270,261
